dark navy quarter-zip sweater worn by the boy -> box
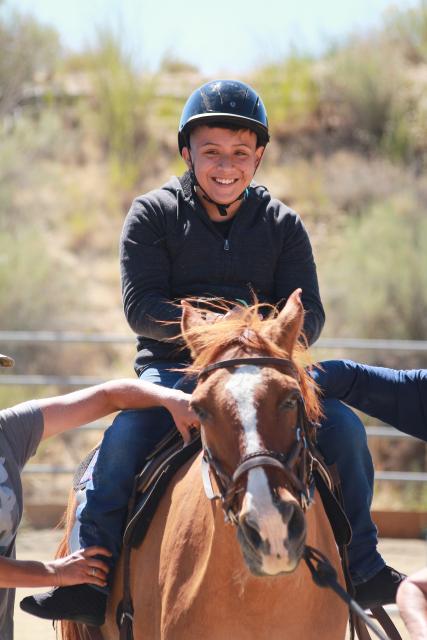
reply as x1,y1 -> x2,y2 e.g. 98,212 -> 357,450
120,174 -> 325,371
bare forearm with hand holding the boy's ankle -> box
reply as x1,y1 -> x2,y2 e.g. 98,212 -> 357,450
0,547 -> 111,589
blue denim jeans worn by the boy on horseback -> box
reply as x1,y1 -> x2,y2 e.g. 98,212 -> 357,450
77,362 -> 384,583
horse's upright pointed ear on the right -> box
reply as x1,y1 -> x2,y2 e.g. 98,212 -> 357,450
267,289 -> 304,357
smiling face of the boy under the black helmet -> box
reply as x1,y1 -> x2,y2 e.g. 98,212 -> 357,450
182,125 -> 264,220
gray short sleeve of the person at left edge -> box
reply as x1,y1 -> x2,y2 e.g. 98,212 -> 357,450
0,400 -> 44,469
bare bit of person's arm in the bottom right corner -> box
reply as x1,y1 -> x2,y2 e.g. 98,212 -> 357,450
396,569 -> 427,640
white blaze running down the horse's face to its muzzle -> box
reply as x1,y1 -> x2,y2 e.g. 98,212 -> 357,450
225,365 -> 298,575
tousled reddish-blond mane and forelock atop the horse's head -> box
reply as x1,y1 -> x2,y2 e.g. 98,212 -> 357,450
182,300 -> 322,422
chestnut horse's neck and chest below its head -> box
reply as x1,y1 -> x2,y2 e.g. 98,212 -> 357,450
102,458 -> 346,640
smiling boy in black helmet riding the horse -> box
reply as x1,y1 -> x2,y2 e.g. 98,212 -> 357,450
21,80 -> 404,624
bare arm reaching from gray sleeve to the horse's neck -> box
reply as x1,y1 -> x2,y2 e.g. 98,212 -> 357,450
38,379 -> 199,442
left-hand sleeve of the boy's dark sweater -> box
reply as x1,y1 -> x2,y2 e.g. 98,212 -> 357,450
120,199 -> 181,342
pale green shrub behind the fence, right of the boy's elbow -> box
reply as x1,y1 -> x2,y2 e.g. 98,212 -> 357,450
318,194 -> 427,339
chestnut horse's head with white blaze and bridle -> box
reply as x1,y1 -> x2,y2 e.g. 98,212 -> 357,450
182,290 -> 319,575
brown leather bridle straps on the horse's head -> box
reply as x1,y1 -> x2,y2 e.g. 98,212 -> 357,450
198,356 -> 316,524
